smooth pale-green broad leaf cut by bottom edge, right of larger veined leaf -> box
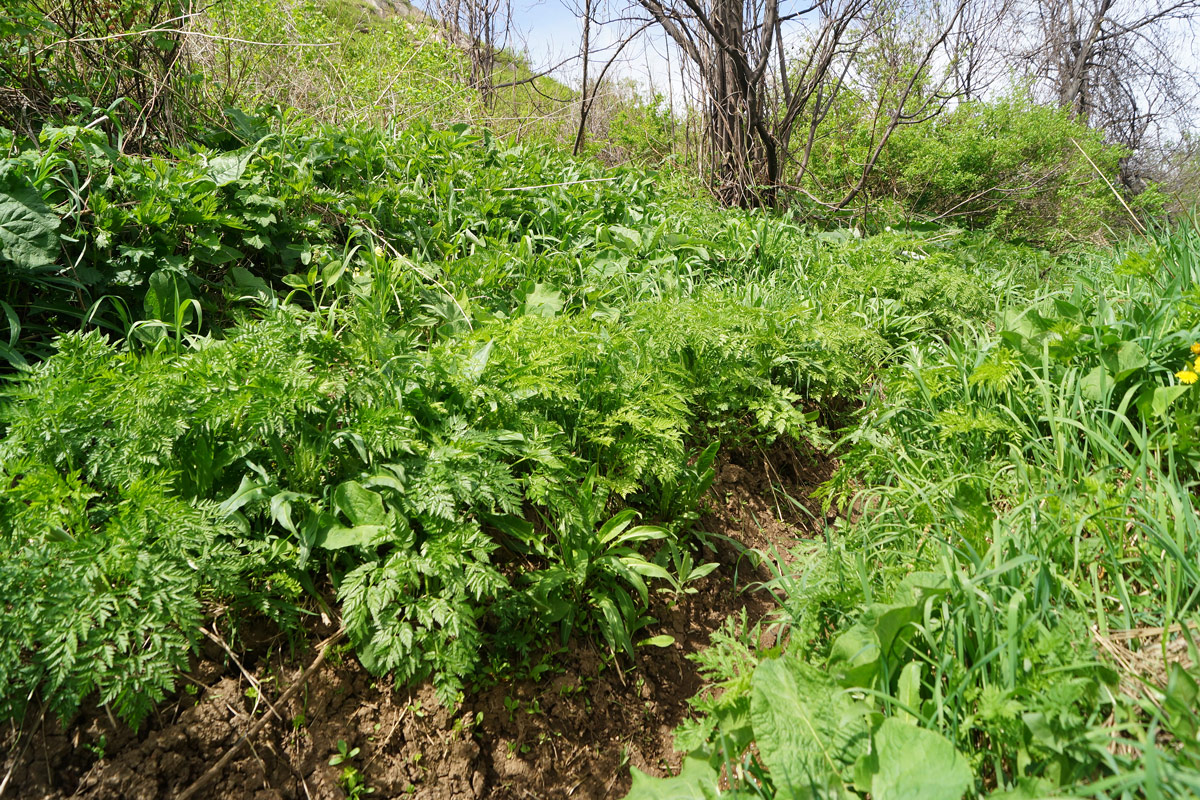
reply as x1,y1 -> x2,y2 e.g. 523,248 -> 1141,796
871,717 -> 974,800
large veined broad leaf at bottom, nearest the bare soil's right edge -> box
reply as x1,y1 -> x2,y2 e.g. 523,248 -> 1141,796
750,655 -> 870,790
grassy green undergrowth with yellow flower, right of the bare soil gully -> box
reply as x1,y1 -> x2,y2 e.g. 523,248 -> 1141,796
629,228 -> 1200,800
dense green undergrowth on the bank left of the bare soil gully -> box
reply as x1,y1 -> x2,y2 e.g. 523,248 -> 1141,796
0,112 -> 1056,722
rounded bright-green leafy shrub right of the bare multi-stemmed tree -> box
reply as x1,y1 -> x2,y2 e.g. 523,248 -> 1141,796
811,88 -> 1163,247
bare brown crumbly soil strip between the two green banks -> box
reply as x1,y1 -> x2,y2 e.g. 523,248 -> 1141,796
0,449 -> 832,800
